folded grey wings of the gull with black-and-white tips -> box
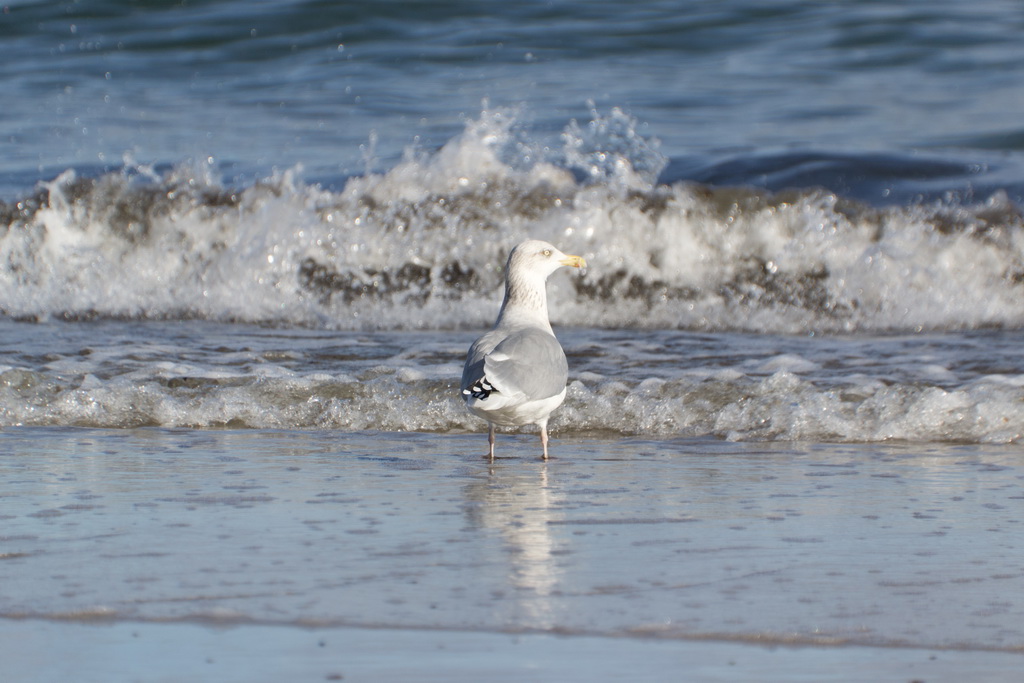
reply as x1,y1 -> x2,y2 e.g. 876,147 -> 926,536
462,329 -> 568,400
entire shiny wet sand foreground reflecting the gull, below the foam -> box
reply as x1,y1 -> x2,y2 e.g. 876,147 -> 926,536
0,428 -> 1024,681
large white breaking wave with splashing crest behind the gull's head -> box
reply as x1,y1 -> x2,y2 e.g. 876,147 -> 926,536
0,110 -> 1024,333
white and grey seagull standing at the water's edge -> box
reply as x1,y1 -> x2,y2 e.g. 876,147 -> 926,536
462,240 -> 587,462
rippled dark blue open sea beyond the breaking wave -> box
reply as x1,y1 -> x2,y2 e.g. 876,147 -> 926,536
6,0 -> 1024,200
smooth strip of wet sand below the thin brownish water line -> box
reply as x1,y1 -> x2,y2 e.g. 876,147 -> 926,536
0,618 -> 1024,682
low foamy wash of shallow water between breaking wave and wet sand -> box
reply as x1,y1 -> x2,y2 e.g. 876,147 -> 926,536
0,323 -> 1024,443
